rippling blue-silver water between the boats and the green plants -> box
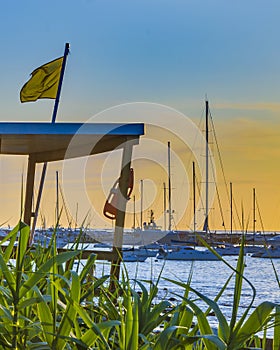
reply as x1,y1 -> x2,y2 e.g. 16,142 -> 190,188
93,255 -> 280,334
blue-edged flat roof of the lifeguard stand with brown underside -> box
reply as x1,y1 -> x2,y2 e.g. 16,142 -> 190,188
0,123 -> 144,163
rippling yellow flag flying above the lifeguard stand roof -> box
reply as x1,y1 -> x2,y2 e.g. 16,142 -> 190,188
20,57 -> 63,102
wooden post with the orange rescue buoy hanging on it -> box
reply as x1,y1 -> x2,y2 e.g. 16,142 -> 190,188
110,139 -> 134,292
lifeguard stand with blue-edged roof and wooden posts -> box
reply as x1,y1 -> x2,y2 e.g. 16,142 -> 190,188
0,122 -> 144,280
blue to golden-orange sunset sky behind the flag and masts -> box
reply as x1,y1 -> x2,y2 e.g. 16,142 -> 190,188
0,0 -> 280,230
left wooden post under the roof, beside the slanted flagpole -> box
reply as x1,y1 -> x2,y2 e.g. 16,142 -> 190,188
23,154 -> 36,234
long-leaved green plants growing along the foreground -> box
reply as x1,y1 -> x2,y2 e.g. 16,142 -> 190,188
0,222 -> 280,350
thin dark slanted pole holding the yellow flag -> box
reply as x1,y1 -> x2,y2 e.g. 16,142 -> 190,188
29,43 -> 70,245
